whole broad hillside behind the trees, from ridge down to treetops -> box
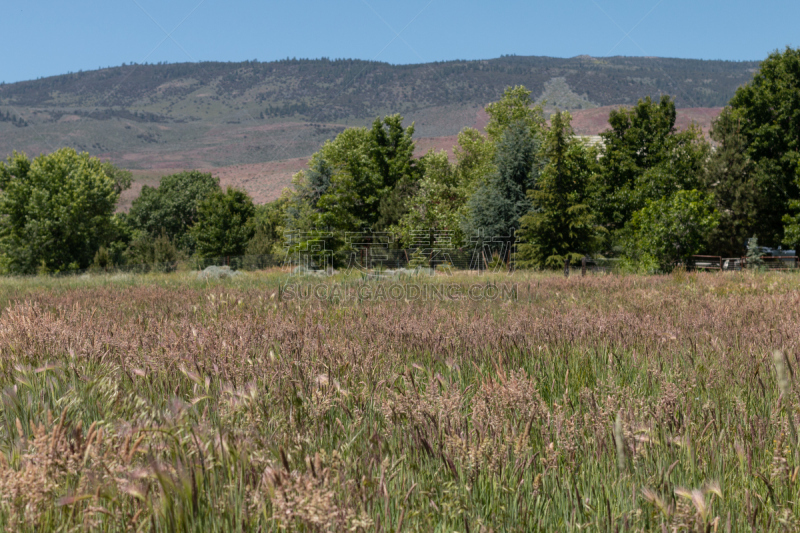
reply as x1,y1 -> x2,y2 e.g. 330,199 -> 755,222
0,56 -> 758,202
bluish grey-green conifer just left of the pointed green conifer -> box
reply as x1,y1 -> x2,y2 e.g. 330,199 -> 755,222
463,122 -> 540,248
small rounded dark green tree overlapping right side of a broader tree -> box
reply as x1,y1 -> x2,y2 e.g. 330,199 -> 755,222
190,187 -> 255,257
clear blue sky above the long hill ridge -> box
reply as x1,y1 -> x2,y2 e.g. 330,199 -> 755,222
0,0 -> 800,82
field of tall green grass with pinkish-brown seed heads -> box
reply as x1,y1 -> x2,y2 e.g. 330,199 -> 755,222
0,273 -> 800,532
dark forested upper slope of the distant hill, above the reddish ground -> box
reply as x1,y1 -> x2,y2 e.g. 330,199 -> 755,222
0,56 -> 758,112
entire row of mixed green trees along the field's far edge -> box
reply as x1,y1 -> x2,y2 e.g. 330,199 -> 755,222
0,48 -> 800,273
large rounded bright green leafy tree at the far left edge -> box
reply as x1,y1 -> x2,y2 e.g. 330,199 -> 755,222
0,148 -> 119,274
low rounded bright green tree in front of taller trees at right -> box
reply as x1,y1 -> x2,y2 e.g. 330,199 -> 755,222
622,190 -> 719,271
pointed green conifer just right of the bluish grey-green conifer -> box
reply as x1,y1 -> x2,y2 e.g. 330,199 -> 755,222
519,112 -> 598,268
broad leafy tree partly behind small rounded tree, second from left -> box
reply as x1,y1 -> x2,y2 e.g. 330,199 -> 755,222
127,170 -> 221,253
